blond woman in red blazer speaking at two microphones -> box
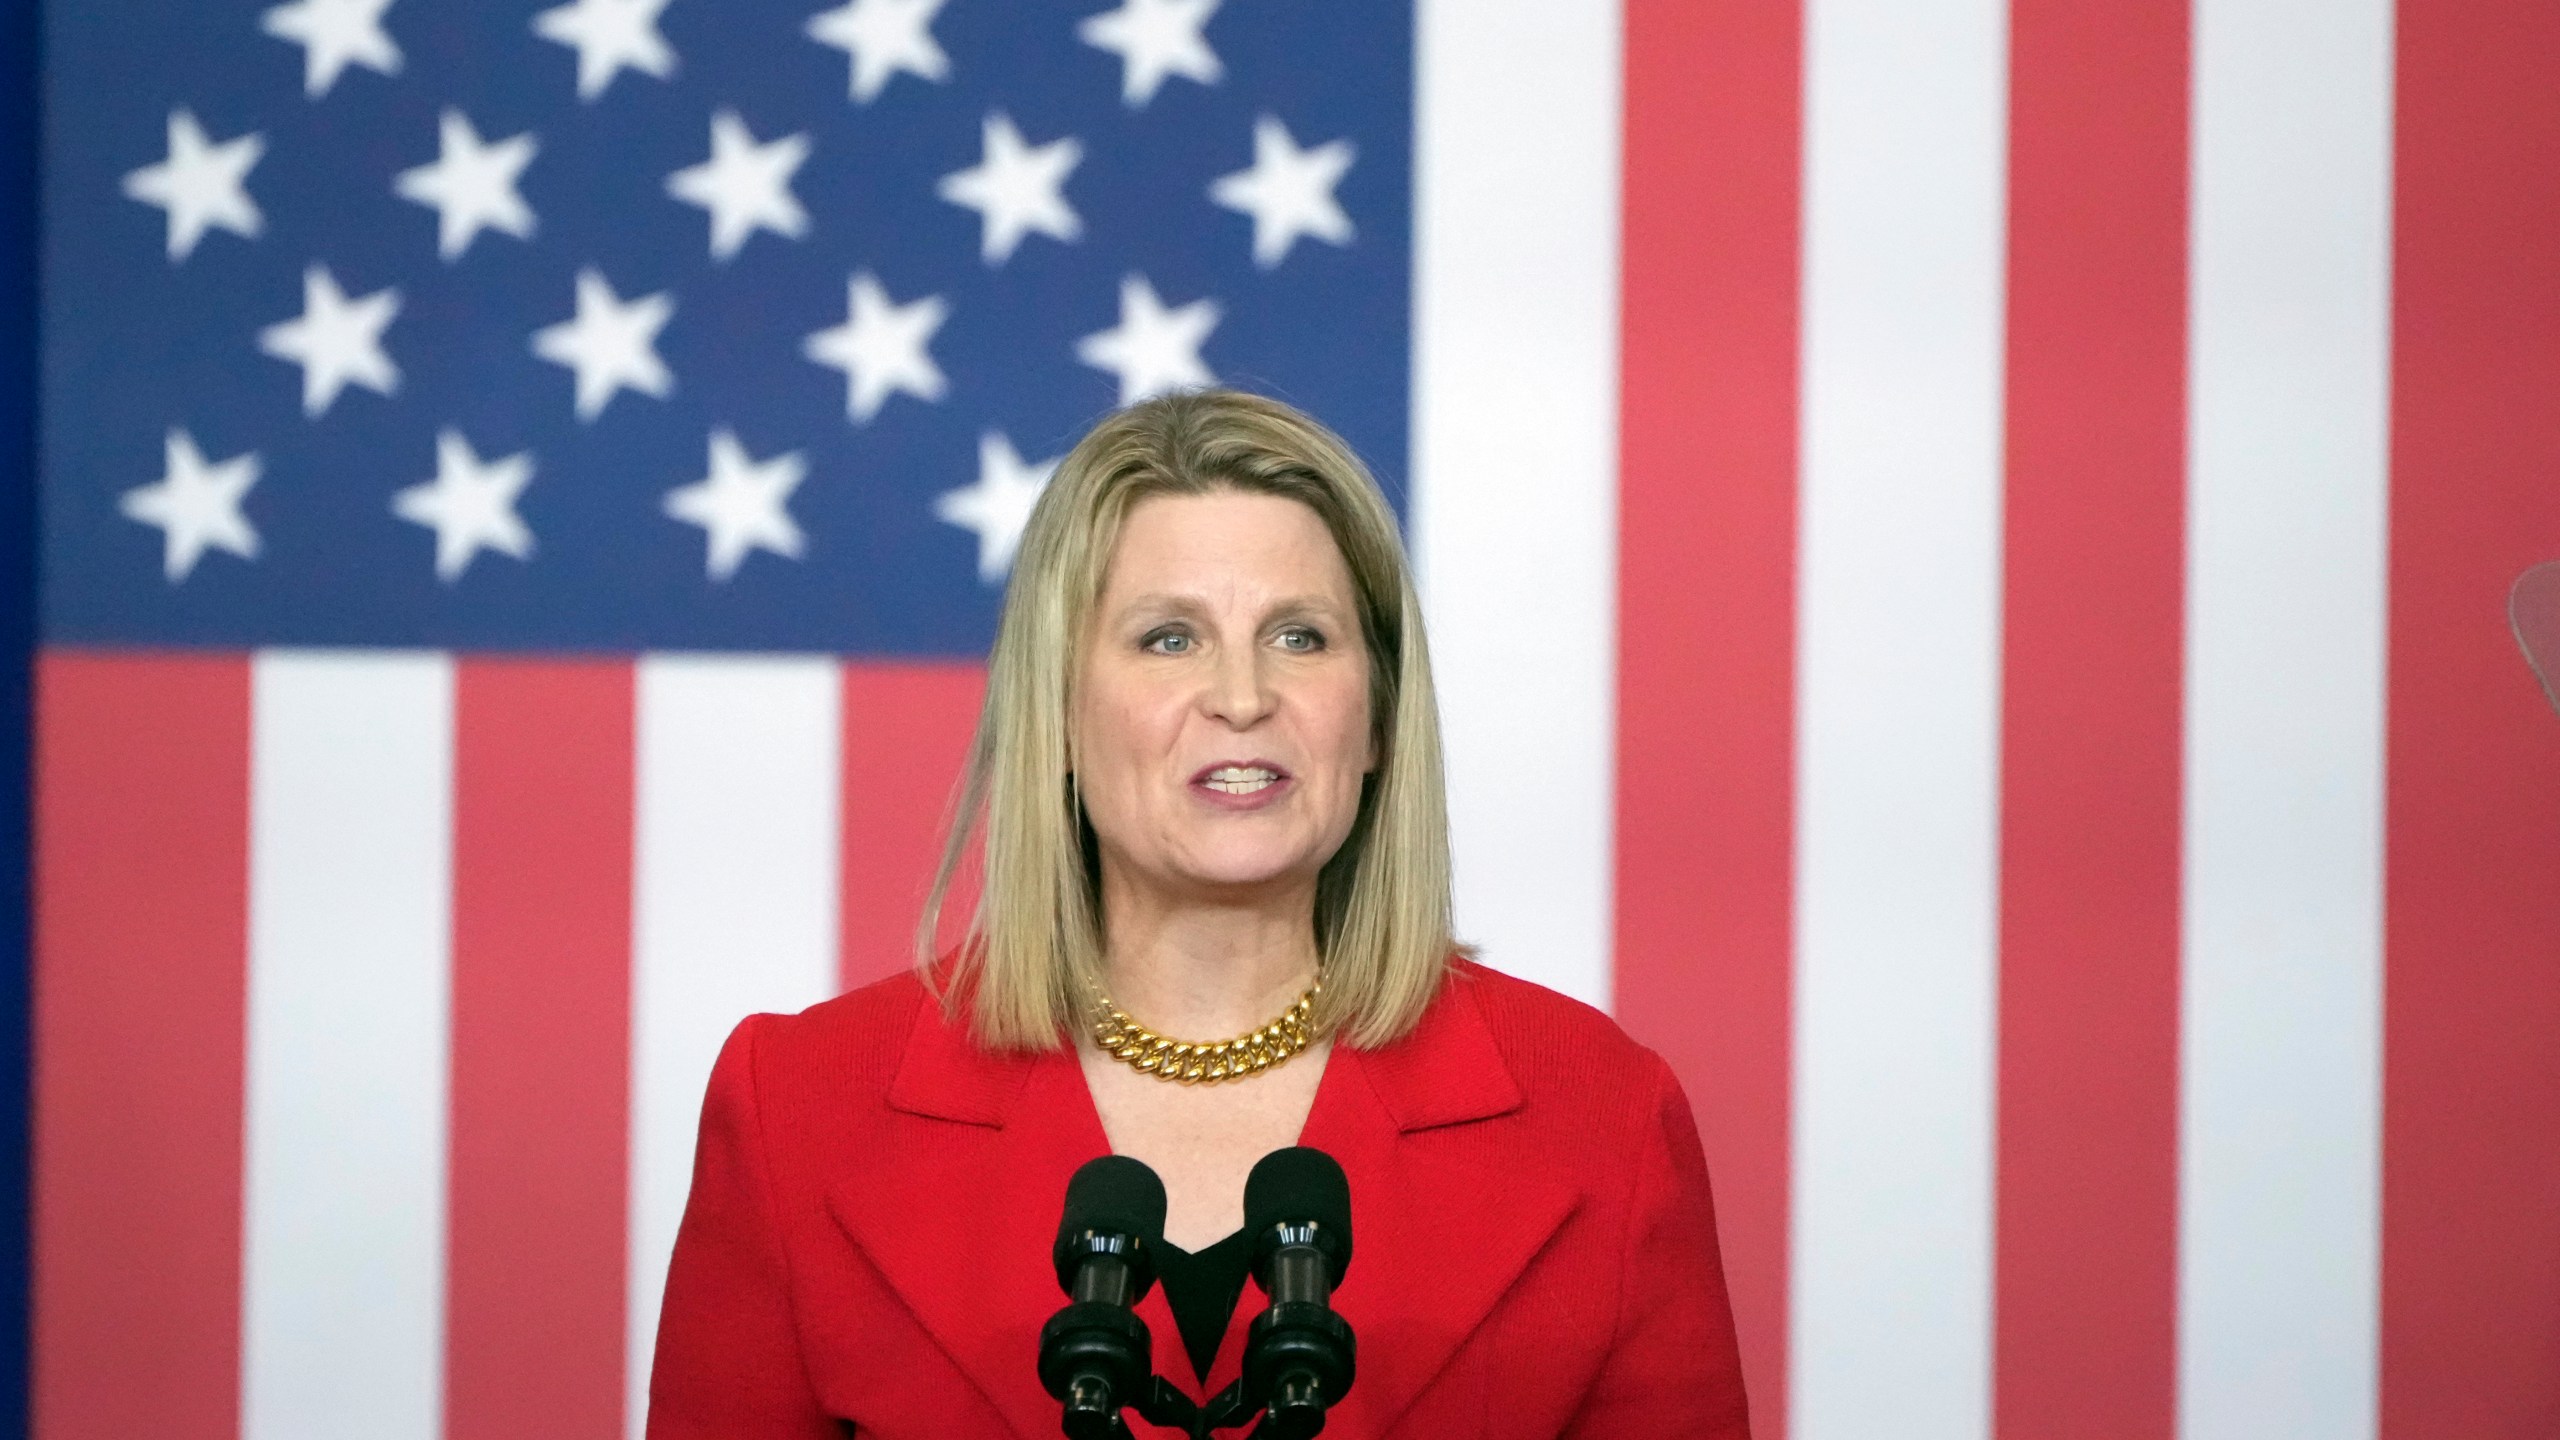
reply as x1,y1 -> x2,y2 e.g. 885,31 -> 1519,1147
648,392 -> 1748,1440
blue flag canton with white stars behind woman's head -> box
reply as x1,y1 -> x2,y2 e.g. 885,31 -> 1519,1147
44,0 -> 1413,656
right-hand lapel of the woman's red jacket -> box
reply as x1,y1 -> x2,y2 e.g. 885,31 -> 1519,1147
1300,971 -> 1580,1435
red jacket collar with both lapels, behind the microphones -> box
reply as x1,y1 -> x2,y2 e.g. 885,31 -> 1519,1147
829,963 -> 1580,1440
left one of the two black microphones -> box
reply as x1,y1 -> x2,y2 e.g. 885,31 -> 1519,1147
1039,1156 -> 1165,1440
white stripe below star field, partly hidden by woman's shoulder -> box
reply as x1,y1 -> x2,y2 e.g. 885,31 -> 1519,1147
625,656 -> 842,1437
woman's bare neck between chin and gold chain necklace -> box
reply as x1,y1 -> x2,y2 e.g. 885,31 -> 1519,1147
1103,869 -> 1316,1040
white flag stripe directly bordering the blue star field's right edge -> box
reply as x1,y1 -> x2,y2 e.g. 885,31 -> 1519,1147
1413,0 -> 1620,1004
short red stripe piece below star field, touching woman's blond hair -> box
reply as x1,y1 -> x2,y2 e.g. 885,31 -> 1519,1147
840,661 -> 986,989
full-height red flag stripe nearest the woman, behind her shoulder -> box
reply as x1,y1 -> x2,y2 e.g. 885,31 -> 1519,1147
1615,0 -> 1802,1440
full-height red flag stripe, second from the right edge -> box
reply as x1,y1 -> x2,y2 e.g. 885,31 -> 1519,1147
1994,0 -> 2186,1440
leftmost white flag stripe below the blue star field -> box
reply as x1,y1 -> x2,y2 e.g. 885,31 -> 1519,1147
241,651 -> 453,1440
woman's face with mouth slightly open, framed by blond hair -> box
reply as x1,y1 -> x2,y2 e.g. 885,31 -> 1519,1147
1073,492 -> 1377,899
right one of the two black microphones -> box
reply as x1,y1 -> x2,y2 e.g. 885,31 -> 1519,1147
1244,1145 -> 1354,1440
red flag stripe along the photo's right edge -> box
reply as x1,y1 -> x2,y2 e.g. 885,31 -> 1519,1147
2381,0 -> 2560,1440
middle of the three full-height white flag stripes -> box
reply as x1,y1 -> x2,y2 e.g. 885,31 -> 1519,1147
1789,0 -> 2007,1440
